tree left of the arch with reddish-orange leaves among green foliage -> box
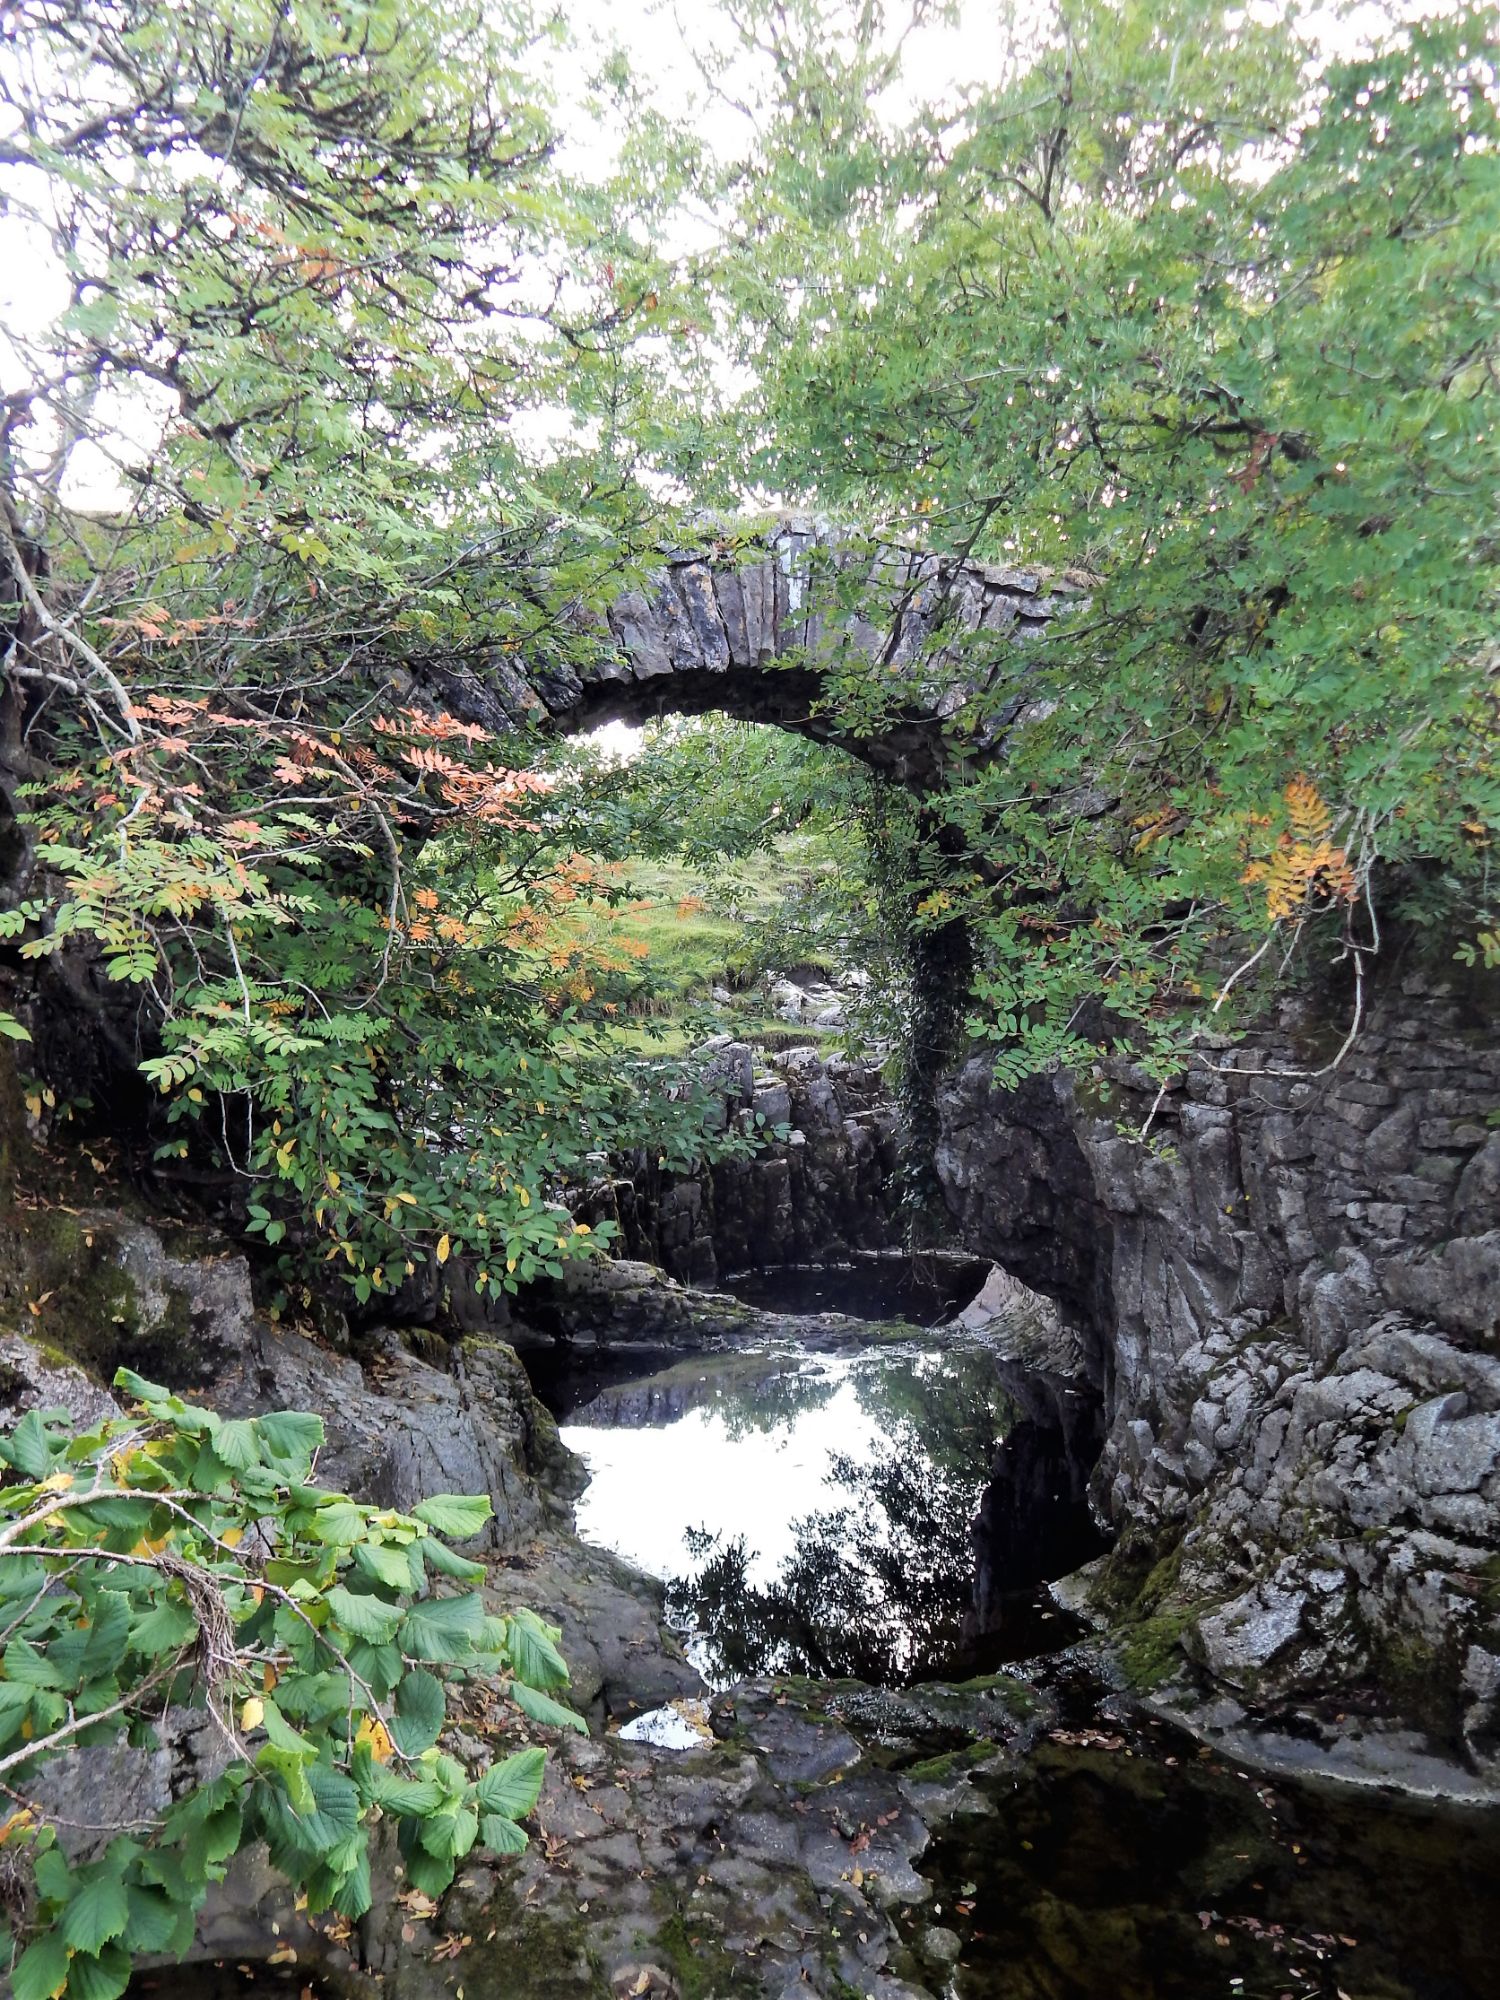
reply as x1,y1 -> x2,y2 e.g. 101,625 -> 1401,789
0,0 -> 740,1302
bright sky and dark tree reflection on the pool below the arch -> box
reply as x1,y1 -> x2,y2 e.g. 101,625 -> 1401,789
562,1346 -> 1012,1684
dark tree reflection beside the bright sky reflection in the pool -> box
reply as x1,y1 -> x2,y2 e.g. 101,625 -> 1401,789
668,1352 -> 1014,1682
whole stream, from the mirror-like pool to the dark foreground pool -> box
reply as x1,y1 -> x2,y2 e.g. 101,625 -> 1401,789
532,1272 -> 1500,2000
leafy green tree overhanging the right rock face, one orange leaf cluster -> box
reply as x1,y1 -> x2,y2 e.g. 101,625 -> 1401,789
702,0 -> 1500,1078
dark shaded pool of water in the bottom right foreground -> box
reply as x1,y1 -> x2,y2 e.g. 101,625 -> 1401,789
922,1720 -> 1500,2000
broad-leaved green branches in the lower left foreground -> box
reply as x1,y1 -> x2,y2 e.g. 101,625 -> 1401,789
0,1370 -> 584,2000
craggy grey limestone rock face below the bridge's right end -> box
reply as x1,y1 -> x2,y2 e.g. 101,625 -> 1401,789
938,974 -> 1500,1756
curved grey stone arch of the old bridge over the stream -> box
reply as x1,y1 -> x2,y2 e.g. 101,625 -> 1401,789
418,518 -> 1084,790
